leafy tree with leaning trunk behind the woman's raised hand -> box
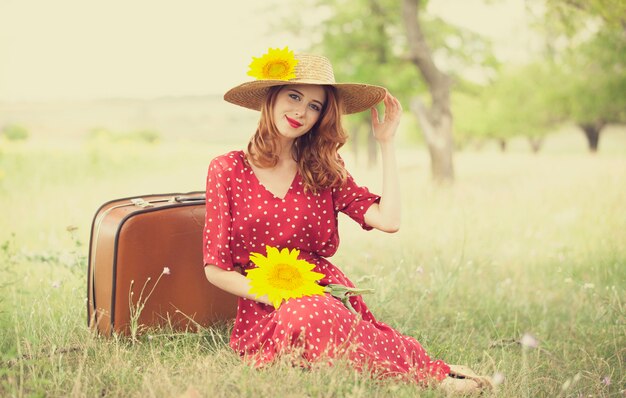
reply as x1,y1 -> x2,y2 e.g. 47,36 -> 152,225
276,0 -> 494,181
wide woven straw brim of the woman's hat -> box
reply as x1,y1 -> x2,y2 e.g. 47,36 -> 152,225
224,79 -> 387,115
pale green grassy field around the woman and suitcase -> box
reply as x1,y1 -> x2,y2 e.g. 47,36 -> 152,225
0,130 -> 626,397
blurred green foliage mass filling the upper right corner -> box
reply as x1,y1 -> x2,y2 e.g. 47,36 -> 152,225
453,0 -> 626,148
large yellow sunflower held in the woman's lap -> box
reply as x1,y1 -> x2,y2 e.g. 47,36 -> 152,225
246,246 -> 324,308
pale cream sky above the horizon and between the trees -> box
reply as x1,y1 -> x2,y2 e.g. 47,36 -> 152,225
0,0 -> 536,101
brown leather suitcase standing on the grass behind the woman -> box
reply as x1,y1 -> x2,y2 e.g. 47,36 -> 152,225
87,192 -> 237,335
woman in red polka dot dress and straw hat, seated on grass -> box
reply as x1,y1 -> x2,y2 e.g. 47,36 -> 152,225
204,48 -> 486,391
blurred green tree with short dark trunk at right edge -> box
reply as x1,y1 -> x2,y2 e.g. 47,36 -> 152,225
545,0 -> 626,152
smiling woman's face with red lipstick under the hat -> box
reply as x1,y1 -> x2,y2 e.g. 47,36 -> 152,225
272,84 -> 326,139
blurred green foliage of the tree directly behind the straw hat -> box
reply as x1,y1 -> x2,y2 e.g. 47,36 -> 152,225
276,0 -> 497,134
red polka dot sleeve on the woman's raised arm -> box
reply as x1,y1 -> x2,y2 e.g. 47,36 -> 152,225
333,173 -> 380,231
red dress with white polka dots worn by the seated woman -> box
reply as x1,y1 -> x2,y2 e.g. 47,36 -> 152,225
204,151 -> 449,382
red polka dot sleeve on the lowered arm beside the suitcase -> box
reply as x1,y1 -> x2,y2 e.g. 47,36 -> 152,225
203,160 -> 234,271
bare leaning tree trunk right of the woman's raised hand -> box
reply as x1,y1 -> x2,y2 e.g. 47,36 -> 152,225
402,0 -> 454,182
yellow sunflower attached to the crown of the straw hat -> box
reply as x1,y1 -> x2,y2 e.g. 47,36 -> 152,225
248,47 -> 298,80
